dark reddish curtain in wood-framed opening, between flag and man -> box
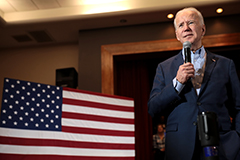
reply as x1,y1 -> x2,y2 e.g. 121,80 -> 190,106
114,56 -> 158,160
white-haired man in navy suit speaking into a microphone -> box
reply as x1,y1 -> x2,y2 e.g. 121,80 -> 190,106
148,8 -> 240,160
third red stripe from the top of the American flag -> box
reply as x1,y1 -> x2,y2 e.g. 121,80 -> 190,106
62,112 -> 134,124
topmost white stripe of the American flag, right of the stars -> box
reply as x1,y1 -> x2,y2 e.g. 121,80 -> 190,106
63,90 -> 134,107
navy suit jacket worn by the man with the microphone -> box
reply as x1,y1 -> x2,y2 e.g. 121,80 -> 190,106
148,50 -> 240,160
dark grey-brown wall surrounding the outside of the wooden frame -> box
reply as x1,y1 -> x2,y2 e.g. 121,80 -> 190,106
78,14 -> 240,92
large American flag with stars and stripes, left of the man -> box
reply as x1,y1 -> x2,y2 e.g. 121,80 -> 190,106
0,78 -> 135,160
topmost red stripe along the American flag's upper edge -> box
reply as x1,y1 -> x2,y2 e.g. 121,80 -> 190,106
63,87 -> 133,101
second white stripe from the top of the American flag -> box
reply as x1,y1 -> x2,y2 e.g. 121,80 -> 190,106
62,104 -> 134,119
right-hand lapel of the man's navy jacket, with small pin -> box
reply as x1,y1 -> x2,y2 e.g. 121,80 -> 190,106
199,50 -> 218,97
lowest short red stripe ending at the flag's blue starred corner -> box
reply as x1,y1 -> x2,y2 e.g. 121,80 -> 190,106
62,126 -> 135,137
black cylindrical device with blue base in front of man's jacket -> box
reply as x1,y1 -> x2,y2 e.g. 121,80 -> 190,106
197,112 -> 219,160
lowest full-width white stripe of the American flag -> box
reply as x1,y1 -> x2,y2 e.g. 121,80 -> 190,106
0,145 -> 135,157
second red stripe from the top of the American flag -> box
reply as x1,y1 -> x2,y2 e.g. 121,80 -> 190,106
63,97 -> 134,112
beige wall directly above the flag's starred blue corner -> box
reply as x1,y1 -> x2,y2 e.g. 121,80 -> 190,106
0,44 -> 79,107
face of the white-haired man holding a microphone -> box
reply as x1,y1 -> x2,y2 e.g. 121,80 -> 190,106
175,10 -> 205,47
